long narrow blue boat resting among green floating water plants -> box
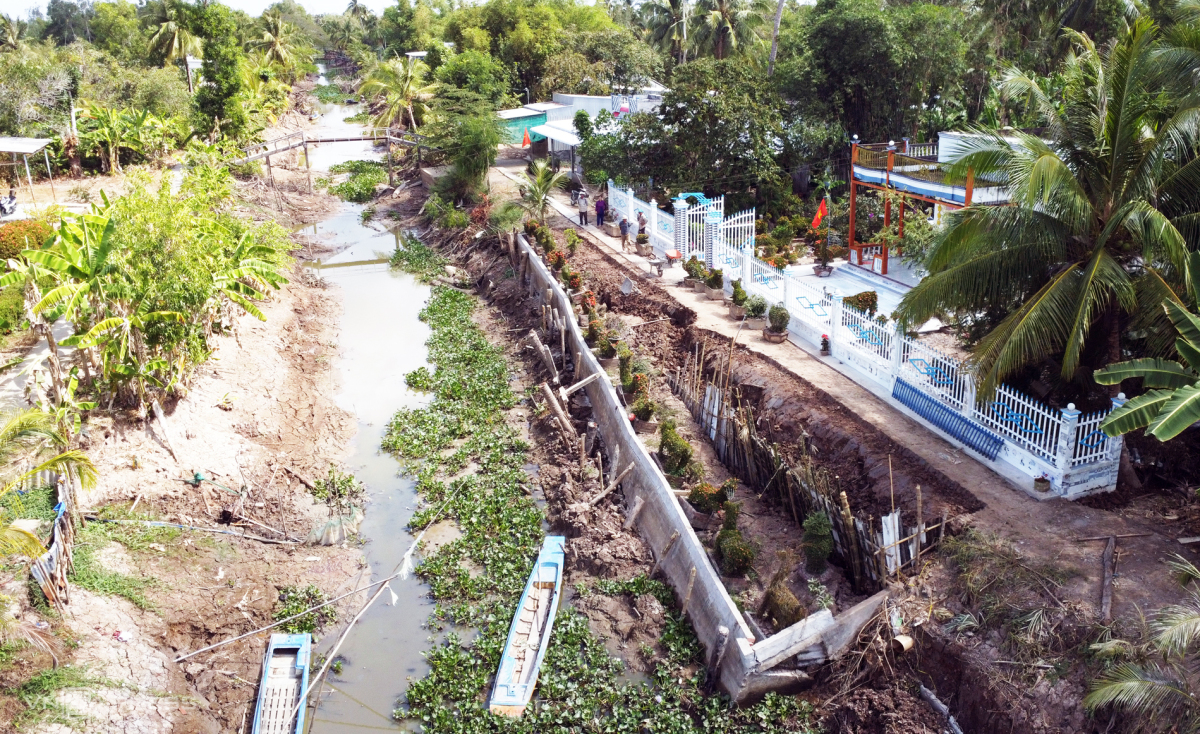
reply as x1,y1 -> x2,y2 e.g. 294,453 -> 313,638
488,535 -> 566,716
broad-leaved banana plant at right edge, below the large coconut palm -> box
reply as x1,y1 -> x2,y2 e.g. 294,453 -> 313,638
1093,257 -> 1200,441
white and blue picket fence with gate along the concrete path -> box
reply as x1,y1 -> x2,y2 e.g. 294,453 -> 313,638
608,181 -> 1124,498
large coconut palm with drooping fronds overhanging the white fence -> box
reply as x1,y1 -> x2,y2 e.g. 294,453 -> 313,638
898,19 -> 1200,395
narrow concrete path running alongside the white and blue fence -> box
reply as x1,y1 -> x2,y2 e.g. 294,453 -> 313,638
500,170 -> 1195,615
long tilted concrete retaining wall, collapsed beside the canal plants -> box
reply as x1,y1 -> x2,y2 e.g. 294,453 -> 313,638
506,235 -> 887,702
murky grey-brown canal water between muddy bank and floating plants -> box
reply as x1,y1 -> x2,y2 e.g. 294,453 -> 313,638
305,67 -> 433,734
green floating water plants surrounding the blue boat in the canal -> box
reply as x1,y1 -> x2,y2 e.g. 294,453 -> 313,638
383,284 -> 818,734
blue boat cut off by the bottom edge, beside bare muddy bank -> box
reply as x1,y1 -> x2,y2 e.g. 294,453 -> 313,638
251,633 -> 312,734
